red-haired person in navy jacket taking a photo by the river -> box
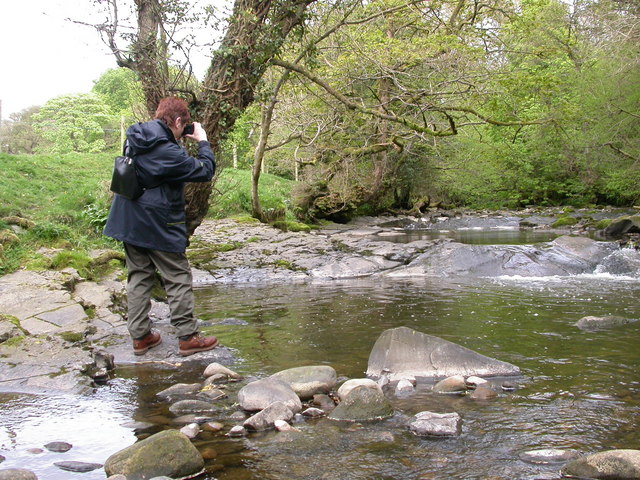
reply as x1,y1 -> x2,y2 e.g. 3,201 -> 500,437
104,97 -> 218,356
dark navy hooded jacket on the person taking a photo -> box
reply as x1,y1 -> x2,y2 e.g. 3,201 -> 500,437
104,120 -> 216,253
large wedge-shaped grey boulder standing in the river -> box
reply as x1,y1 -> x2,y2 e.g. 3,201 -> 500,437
367,327 -> 520,381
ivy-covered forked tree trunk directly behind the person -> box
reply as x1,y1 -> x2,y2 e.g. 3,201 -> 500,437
89,0 -> 315,234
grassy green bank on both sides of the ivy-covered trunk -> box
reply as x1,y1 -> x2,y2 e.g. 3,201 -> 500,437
0,154 -> 292,276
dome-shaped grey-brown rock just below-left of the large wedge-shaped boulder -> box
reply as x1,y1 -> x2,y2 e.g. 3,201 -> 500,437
328,386 -> 393,422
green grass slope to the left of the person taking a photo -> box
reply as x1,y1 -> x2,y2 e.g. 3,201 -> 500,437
0,153 -> 116,274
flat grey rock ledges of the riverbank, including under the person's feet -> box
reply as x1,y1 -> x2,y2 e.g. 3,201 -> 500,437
0,206 -> 640,393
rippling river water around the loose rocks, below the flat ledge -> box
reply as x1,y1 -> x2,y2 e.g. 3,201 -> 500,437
0,231 -> 640,480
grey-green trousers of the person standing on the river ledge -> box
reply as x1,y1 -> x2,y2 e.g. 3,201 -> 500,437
124,243 -> 198,339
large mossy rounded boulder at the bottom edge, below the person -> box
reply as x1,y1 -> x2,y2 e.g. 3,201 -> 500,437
104,430 -> 204,480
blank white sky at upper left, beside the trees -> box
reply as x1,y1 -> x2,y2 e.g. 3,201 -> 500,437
0,0 -> 230,120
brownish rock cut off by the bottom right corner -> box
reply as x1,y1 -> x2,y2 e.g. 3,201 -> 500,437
561,449 -> 640,480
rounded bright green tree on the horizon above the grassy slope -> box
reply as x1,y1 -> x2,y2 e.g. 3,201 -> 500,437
33,94 -> 117,153
